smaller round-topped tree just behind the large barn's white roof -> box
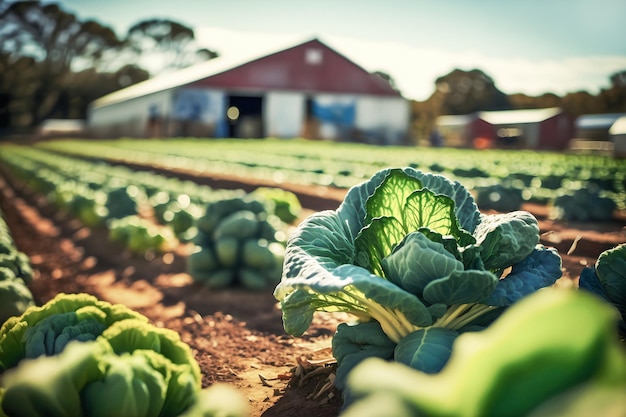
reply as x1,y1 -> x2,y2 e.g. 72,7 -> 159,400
126,19 -> 218,74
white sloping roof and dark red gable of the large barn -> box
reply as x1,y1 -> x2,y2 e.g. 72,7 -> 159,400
92,39 -> 400,107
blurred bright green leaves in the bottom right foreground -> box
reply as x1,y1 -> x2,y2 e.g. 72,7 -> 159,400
342,288 -> 626,417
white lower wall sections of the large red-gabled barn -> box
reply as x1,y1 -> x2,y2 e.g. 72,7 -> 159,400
88,87 -> 410,145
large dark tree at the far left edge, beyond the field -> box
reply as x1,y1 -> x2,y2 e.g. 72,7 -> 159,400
0,2 -> 123,126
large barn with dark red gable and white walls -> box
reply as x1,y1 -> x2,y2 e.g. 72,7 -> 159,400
88,39 -> 410,144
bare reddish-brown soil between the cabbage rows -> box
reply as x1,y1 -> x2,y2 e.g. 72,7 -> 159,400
0,163 -> 626,417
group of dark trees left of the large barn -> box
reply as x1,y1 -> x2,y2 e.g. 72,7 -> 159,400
0,0 -> 217,134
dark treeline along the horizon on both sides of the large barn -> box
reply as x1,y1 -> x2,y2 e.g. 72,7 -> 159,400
0,0 -> 626,139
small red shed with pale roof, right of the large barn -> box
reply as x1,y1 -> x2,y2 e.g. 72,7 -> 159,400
436,107 -> 573,149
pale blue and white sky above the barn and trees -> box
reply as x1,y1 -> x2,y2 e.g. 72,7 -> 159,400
51,0 -> 626,101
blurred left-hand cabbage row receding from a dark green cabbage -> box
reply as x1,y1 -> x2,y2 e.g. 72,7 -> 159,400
2,146 -> 300,289
